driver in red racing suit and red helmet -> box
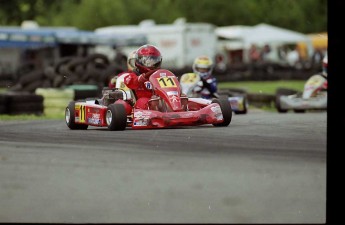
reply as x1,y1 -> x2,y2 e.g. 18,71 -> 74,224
124,44 -> 162,109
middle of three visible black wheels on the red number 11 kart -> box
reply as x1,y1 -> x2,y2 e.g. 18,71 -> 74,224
105,104 -> 127,130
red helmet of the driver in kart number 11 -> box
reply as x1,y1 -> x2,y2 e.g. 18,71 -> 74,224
135,45 -> 162,73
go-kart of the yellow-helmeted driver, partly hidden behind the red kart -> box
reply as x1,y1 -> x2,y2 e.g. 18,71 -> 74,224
180,73 -> 248,114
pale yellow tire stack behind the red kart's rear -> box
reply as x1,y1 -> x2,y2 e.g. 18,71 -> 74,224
35,88 -> 74,117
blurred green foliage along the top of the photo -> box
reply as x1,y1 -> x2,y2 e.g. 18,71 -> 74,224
0,0 -> 327,33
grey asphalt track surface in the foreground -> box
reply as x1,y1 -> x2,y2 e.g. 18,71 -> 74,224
0,111 -> 327,223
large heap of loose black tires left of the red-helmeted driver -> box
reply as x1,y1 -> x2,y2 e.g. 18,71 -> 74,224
8,53 -> 126,95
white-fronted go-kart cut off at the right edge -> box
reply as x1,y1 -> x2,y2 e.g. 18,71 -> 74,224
275,74 -> 327,113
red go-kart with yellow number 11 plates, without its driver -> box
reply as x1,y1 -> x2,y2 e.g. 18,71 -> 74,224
65,69 -> 232,130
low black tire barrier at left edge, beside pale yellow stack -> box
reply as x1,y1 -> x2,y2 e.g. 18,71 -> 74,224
0,92 -> 44,115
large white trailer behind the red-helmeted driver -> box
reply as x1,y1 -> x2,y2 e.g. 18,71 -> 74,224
95,18 -> 217,69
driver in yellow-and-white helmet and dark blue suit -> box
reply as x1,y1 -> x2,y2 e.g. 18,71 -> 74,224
193,55 -> 219,98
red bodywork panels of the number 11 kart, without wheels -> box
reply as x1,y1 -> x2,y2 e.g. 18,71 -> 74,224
74,69 -> 224,129
